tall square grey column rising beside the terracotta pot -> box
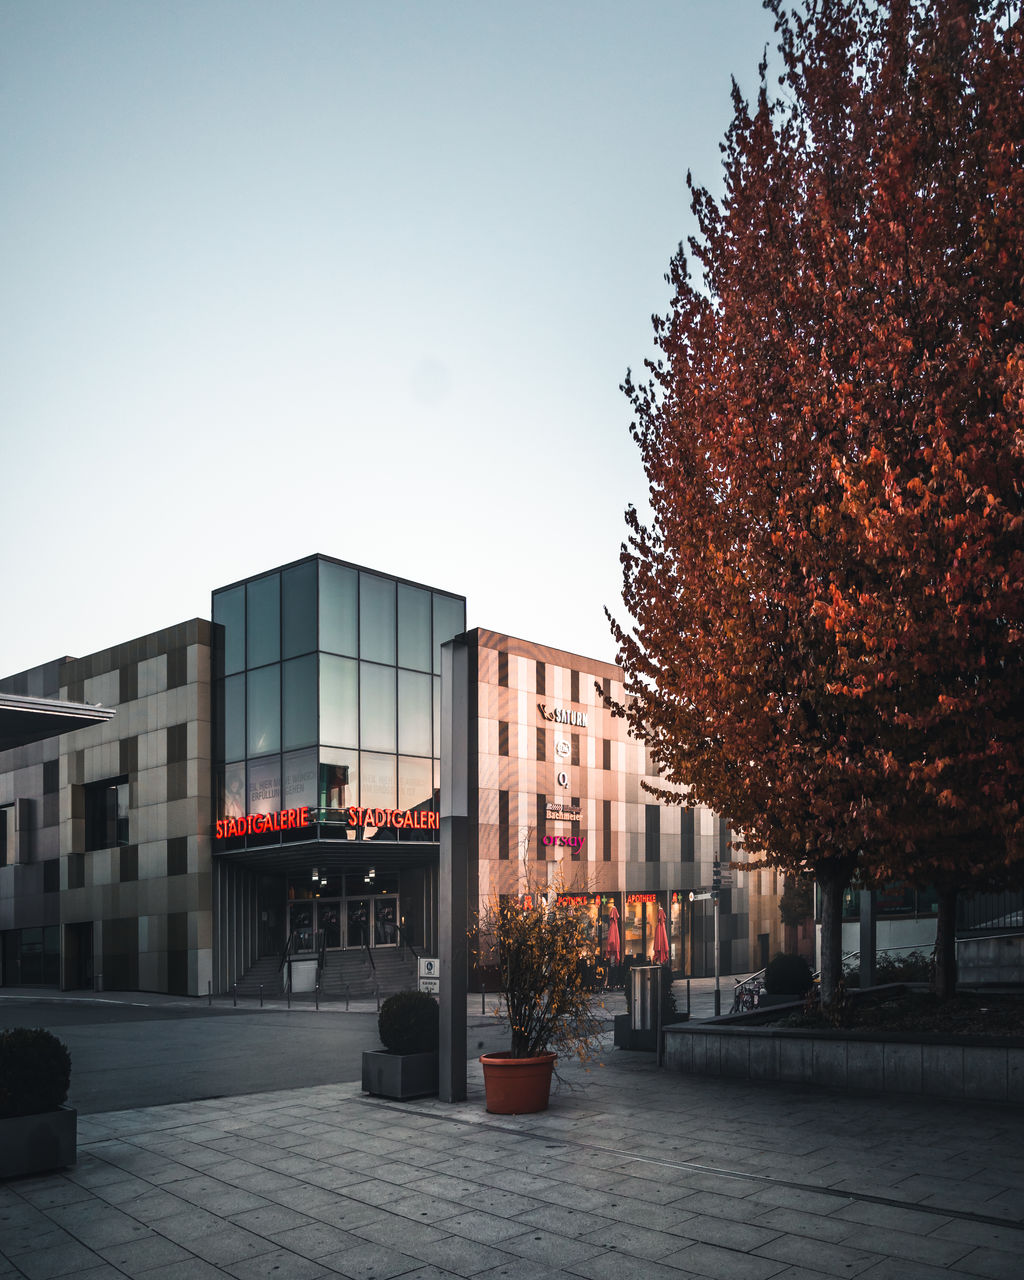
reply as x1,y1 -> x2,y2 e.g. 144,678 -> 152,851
438,636 -> 470,1102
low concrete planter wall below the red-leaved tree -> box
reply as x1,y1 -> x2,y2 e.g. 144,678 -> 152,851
664,1023 -> 1024,1106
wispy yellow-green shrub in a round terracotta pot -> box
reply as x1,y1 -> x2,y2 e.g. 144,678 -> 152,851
480,890 -> 603,1115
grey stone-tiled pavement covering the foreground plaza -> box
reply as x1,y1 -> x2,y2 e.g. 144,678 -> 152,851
0,1051 -> 1024,1280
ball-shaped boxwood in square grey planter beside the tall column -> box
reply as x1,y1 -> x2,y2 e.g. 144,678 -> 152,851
362,991 -> 438,1101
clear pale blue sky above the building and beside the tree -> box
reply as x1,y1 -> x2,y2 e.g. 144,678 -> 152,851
0,0 -> 773,675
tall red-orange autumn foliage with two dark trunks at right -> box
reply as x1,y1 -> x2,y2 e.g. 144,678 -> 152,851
613,0 -> 1024,1002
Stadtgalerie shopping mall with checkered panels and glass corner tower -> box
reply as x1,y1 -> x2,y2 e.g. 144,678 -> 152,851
0,556 -> 782,996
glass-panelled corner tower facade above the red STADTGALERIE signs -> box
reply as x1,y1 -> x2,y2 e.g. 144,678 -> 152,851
212,557 -> 466,847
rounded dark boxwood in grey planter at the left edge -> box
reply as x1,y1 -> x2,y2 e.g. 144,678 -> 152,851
0,1027 -> 78,1178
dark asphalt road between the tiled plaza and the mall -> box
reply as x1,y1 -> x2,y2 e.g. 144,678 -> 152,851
0,996 -> 508,1115
